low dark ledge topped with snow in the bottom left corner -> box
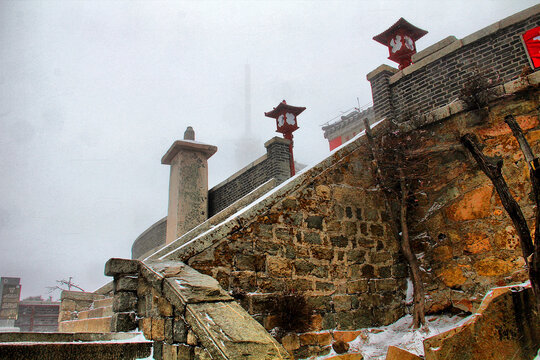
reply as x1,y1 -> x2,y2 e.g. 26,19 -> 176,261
0,333 -> 152,360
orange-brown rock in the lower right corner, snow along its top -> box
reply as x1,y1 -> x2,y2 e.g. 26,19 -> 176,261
424,287 -> 540,360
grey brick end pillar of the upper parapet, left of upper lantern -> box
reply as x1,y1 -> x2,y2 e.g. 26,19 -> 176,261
366,65 -> 398,124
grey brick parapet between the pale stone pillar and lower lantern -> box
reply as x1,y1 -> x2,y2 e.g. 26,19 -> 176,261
208,137 -> 291,216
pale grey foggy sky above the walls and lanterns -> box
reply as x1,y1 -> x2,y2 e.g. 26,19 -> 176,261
0,0 -> 537,298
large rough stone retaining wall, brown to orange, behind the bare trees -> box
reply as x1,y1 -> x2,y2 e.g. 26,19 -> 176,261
151,72 -> 540,351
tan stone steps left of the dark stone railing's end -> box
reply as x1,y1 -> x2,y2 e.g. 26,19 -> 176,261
58,291 -> 113,333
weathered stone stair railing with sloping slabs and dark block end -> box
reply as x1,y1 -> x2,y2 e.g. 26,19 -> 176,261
105,259 -> 290,359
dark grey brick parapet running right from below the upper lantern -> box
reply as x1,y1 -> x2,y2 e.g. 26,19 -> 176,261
370,6 -> 540,121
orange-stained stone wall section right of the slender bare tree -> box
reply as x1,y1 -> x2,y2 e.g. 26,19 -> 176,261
402,84 -> 540,312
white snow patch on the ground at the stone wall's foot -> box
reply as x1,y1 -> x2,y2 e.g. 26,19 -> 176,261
318,315 -> 468,360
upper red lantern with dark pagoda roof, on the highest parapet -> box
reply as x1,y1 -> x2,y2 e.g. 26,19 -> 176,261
373,18 -> 427,70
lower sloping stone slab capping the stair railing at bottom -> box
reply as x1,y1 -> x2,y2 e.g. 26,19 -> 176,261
186,302 -> 289,359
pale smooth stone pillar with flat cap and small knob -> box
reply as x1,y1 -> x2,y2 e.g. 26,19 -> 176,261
161,126 -> 217,244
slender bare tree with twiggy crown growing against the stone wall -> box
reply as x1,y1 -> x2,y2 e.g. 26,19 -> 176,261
364,121 -> 426,328
